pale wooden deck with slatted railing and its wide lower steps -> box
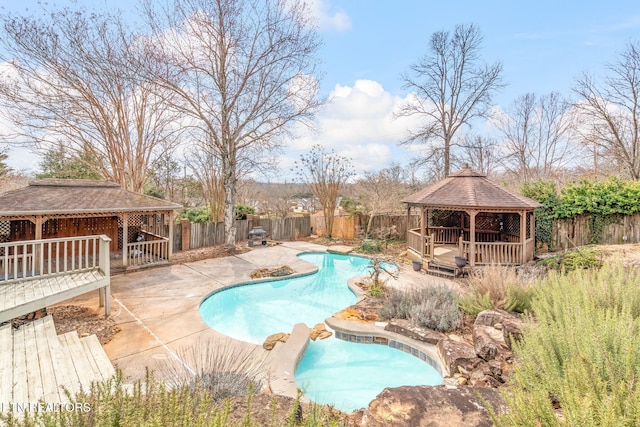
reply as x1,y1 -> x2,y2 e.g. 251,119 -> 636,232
0,236 -> 115,413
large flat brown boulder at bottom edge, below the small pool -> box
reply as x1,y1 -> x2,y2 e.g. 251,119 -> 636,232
360,386 -> 506,427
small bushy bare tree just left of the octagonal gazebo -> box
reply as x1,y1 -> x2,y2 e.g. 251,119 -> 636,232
355,165 -> 411,235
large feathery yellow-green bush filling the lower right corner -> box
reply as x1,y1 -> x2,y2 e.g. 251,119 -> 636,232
493,264 -> 640,427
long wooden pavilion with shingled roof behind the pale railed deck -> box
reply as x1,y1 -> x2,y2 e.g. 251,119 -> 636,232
0,179 -> 182,266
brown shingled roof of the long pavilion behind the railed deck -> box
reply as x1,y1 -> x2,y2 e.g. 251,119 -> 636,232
0,178 -> 182,216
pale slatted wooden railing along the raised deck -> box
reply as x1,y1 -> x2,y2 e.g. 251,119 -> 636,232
0,235 -> 111,282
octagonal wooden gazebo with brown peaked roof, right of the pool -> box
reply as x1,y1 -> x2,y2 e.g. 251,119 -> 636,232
402,168 -> 541,270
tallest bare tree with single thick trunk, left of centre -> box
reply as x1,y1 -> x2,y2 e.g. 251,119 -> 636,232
146,0 -> 319,250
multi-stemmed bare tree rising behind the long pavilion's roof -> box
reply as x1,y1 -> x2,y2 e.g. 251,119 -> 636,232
0,8 -> 182,192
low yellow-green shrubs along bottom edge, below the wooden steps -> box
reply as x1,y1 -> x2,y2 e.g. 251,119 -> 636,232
0,371 -> 347,427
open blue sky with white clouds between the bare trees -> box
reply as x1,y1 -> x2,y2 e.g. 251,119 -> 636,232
0,0 -> 640,178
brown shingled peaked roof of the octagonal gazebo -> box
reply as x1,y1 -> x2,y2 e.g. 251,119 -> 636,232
402,168 -> 542,209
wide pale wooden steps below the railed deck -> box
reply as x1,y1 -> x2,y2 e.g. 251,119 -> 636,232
0,316 -> 115,411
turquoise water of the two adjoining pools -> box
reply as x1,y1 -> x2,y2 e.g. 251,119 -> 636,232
200,253 -> 442,411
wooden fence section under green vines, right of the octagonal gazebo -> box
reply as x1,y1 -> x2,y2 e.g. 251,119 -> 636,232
551,214 -> 640,250
